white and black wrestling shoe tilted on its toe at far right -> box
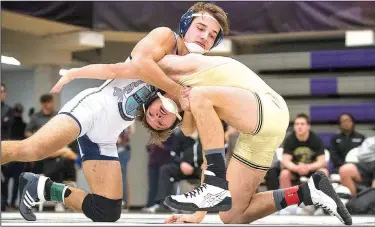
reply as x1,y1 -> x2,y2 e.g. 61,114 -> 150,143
307,171 -> 352,225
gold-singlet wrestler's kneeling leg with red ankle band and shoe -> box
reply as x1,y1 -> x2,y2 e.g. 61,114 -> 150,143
220,158 -> 352,225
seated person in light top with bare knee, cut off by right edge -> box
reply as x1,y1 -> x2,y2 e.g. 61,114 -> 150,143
339,136 -> 375,195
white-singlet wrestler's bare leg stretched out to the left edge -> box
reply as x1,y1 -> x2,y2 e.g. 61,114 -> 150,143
1,114 -> 80,165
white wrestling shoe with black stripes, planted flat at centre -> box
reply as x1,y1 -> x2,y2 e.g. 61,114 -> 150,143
164,170 -> 232,212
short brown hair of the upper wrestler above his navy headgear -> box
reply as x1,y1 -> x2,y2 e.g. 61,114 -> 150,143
188,2 -> 229,35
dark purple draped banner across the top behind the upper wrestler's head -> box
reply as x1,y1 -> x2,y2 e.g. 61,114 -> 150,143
1,1 -> 375,35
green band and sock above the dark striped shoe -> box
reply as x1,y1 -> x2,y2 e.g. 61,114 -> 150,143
44,178 -> 72,203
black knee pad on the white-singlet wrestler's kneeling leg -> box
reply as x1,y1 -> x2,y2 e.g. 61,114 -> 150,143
82,194 -> 122,222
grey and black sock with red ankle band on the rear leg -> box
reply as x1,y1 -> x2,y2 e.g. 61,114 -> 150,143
273,183 -> 313,210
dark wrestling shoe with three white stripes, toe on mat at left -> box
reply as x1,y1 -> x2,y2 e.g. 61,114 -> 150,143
19,172 -> 48,221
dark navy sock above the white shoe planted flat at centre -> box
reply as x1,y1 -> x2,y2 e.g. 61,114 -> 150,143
205,148 -> 226,179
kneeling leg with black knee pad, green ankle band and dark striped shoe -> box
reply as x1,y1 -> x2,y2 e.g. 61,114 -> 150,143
20,160 -> 122,222
